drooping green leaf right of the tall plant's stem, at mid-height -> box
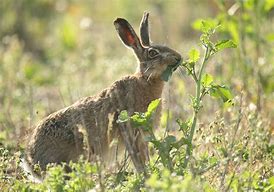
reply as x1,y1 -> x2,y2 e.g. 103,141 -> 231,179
210,85 -> 233,102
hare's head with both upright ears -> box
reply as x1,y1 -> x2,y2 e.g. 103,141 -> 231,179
114,13 -> 181,81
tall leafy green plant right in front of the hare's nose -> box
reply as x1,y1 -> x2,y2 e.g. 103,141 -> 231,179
179,20 -> 236,168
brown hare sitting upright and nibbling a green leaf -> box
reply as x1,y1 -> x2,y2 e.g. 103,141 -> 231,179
25,12 -> 181,172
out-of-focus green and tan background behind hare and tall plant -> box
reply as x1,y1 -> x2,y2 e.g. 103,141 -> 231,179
0,0 -> 274,146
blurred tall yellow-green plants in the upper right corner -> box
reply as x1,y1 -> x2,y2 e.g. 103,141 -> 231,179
202,0 -> 274,110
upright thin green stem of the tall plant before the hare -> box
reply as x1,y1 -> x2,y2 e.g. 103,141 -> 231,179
184,47 -> 210,168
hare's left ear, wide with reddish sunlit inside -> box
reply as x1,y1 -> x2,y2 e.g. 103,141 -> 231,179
114,18 -> 143,53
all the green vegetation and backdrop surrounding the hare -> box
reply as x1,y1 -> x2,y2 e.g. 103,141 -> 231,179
0,0 -> 274,192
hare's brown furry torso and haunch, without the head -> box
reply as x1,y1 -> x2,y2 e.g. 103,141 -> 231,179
28,74 -> 163,169
